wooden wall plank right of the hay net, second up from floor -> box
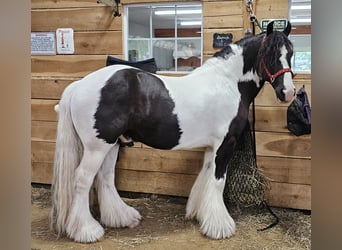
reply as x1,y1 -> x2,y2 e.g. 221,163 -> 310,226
257,156 -> 311,185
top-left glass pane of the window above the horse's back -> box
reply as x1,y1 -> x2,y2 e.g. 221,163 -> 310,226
128,7 -> 150,39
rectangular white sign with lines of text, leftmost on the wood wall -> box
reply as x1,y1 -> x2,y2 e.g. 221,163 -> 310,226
31,32 -> 56,55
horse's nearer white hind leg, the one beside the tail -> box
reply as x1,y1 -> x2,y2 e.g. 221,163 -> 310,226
66,145 -> 111,242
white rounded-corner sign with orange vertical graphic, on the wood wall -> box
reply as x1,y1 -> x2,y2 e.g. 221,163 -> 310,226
56,28 -> 75,54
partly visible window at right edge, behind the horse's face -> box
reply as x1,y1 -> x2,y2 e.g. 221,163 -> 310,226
290,0 -> 311,74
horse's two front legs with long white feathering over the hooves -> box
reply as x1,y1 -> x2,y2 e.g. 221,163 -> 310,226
186,137 -> 235,239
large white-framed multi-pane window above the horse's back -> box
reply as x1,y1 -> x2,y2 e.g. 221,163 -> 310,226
125,2 -> 202,72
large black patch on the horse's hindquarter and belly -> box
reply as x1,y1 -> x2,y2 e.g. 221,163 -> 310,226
94,68 -> 181,149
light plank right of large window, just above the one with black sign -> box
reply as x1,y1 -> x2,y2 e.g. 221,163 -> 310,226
203,15 -> 243,29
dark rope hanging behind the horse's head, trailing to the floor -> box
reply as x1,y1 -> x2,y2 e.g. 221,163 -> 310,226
246,0 -> 279,231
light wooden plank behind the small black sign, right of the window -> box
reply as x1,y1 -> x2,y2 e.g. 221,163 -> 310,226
203,28 -> 243,54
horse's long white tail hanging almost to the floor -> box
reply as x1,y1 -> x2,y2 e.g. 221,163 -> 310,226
51,82 -> 83,235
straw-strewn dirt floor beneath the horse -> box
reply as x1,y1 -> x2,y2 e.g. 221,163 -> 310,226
31,186 -> 311,250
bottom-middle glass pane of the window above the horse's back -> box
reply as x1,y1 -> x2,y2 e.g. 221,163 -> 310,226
153,39 -> 175,71
